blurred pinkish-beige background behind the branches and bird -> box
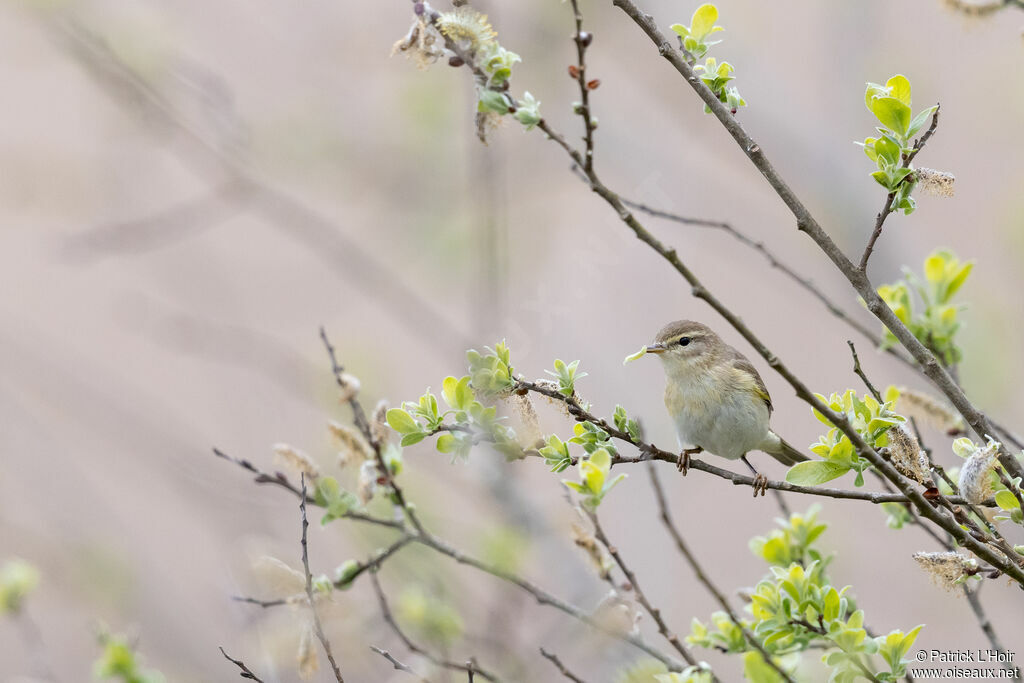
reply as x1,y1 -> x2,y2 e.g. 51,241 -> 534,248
0,0 -> 1024,681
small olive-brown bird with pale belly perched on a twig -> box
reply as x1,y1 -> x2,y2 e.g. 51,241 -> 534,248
643,321 -> 808,496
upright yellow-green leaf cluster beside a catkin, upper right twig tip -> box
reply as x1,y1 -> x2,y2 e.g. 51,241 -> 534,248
858,74 -> 938,214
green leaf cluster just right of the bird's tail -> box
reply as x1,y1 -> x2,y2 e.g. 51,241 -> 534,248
785,387 -> 906,486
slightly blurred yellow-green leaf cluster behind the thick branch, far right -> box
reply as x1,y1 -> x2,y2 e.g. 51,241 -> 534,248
879,249 -> 974,366
